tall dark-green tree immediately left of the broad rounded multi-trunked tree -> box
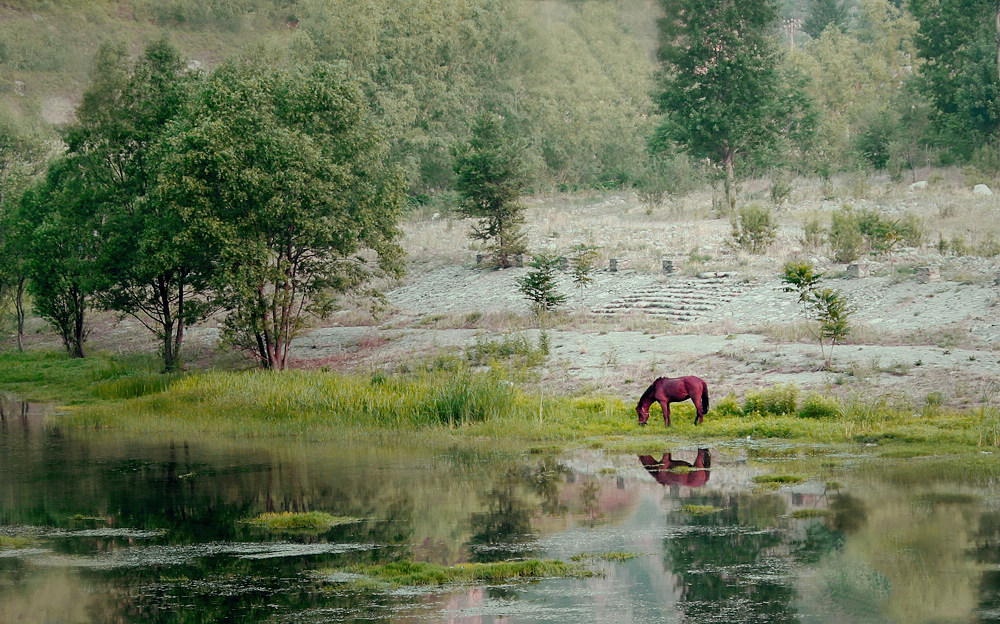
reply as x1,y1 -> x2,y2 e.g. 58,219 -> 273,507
67,39 -> 208,370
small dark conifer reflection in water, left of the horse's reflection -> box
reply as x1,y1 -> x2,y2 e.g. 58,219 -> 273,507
469,470 -> 536,563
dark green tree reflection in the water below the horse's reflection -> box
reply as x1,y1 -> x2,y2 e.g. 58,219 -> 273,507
664,492 -> 797,623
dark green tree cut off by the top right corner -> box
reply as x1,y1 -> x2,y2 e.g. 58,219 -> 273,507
908,0 -> 1000,152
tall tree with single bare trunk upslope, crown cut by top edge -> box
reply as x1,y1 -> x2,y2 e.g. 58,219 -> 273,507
654,0 -> 791,211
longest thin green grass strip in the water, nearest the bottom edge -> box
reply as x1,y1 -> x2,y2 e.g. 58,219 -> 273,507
343,559 -> 594,587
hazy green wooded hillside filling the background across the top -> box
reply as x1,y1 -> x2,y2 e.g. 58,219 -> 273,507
0,0 -> 998,197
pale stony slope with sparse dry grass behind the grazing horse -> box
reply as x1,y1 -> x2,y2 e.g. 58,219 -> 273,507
280,177 -> 1000,409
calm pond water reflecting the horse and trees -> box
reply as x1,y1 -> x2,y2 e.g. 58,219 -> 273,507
0,403 -> 1000,624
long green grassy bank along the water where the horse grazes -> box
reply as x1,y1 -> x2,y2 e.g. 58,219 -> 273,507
0,352 -> 1000,457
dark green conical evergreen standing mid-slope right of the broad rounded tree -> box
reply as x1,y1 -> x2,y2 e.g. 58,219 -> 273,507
454,113 -> 526,268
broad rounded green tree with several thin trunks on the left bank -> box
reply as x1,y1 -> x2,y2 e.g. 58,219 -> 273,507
157,52 -> 405,369
